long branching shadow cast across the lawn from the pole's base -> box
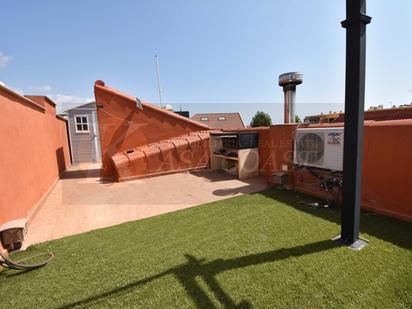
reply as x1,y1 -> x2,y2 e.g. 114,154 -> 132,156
59,239 -> 337,308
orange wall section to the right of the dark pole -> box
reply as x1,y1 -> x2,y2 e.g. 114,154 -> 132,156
362,119 -> 412,221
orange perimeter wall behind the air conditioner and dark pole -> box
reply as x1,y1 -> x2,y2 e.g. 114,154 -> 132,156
259,119 -> 412,221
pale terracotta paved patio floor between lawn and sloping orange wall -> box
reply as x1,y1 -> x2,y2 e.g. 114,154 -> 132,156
25,164 -> 267,246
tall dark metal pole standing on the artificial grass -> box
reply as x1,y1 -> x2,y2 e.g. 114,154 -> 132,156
340,0 -> 371,245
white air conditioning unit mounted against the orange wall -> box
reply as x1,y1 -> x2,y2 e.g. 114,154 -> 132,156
293,128 -> 343,171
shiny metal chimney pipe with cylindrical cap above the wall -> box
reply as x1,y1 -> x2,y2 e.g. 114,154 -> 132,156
279,72 -> 303,123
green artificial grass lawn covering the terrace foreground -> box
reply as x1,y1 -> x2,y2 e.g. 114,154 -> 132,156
0,189 -> 412,308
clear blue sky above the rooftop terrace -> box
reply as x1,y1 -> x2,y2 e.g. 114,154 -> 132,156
0,0 -> 412,123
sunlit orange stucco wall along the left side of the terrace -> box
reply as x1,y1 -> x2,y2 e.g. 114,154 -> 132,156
0,87 -> 70,224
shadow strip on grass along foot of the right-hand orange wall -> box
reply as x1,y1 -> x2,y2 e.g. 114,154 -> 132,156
255,188 -> 412,250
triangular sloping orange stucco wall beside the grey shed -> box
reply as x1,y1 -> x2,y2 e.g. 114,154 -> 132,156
94,81 -> 209,178
